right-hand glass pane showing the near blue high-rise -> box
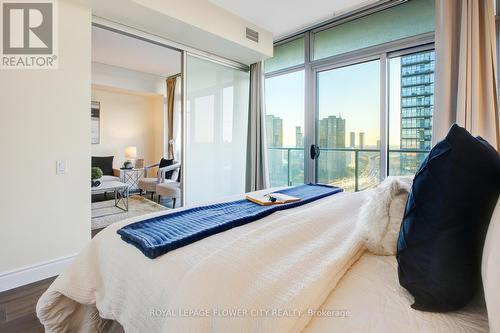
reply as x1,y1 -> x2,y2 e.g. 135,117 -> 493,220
388,50 -> 435,175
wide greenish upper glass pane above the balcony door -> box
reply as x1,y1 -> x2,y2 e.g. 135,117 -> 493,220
313,0 -> 434,60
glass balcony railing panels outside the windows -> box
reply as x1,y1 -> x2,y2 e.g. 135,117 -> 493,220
268,147 -> 429,192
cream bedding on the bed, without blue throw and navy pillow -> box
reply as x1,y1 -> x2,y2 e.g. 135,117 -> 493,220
37,177 -> 500,333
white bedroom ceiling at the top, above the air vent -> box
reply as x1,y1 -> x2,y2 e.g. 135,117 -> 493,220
209,0 -> 380,39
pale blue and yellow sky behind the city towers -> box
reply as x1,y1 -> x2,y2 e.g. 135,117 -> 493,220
265,58 -> 401,147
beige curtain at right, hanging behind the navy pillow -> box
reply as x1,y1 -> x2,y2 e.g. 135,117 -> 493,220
432,0 -> 500,149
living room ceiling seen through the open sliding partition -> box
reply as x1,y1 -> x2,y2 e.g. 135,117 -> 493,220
92,27 -> 181,77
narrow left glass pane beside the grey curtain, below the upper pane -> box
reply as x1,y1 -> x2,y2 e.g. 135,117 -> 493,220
265,70 -> 305,186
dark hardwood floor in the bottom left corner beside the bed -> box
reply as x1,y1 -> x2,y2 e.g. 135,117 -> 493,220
0,277 -> 55,333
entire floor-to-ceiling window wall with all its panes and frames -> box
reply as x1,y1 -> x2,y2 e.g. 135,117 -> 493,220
265,0 -> 435,191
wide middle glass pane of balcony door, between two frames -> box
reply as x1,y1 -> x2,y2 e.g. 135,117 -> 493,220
316,60 -> 380,191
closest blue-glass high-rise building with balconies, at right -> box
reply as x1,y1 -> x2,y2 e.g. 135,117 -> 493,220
400,51 -> 435,172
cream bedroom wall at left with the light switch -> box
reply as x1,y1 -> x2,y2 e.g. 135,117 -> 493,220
0,1 -> 91,282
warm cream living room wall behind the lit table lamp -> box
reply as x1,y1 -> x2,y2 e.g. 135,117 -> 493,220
92,86 -> 164,168
